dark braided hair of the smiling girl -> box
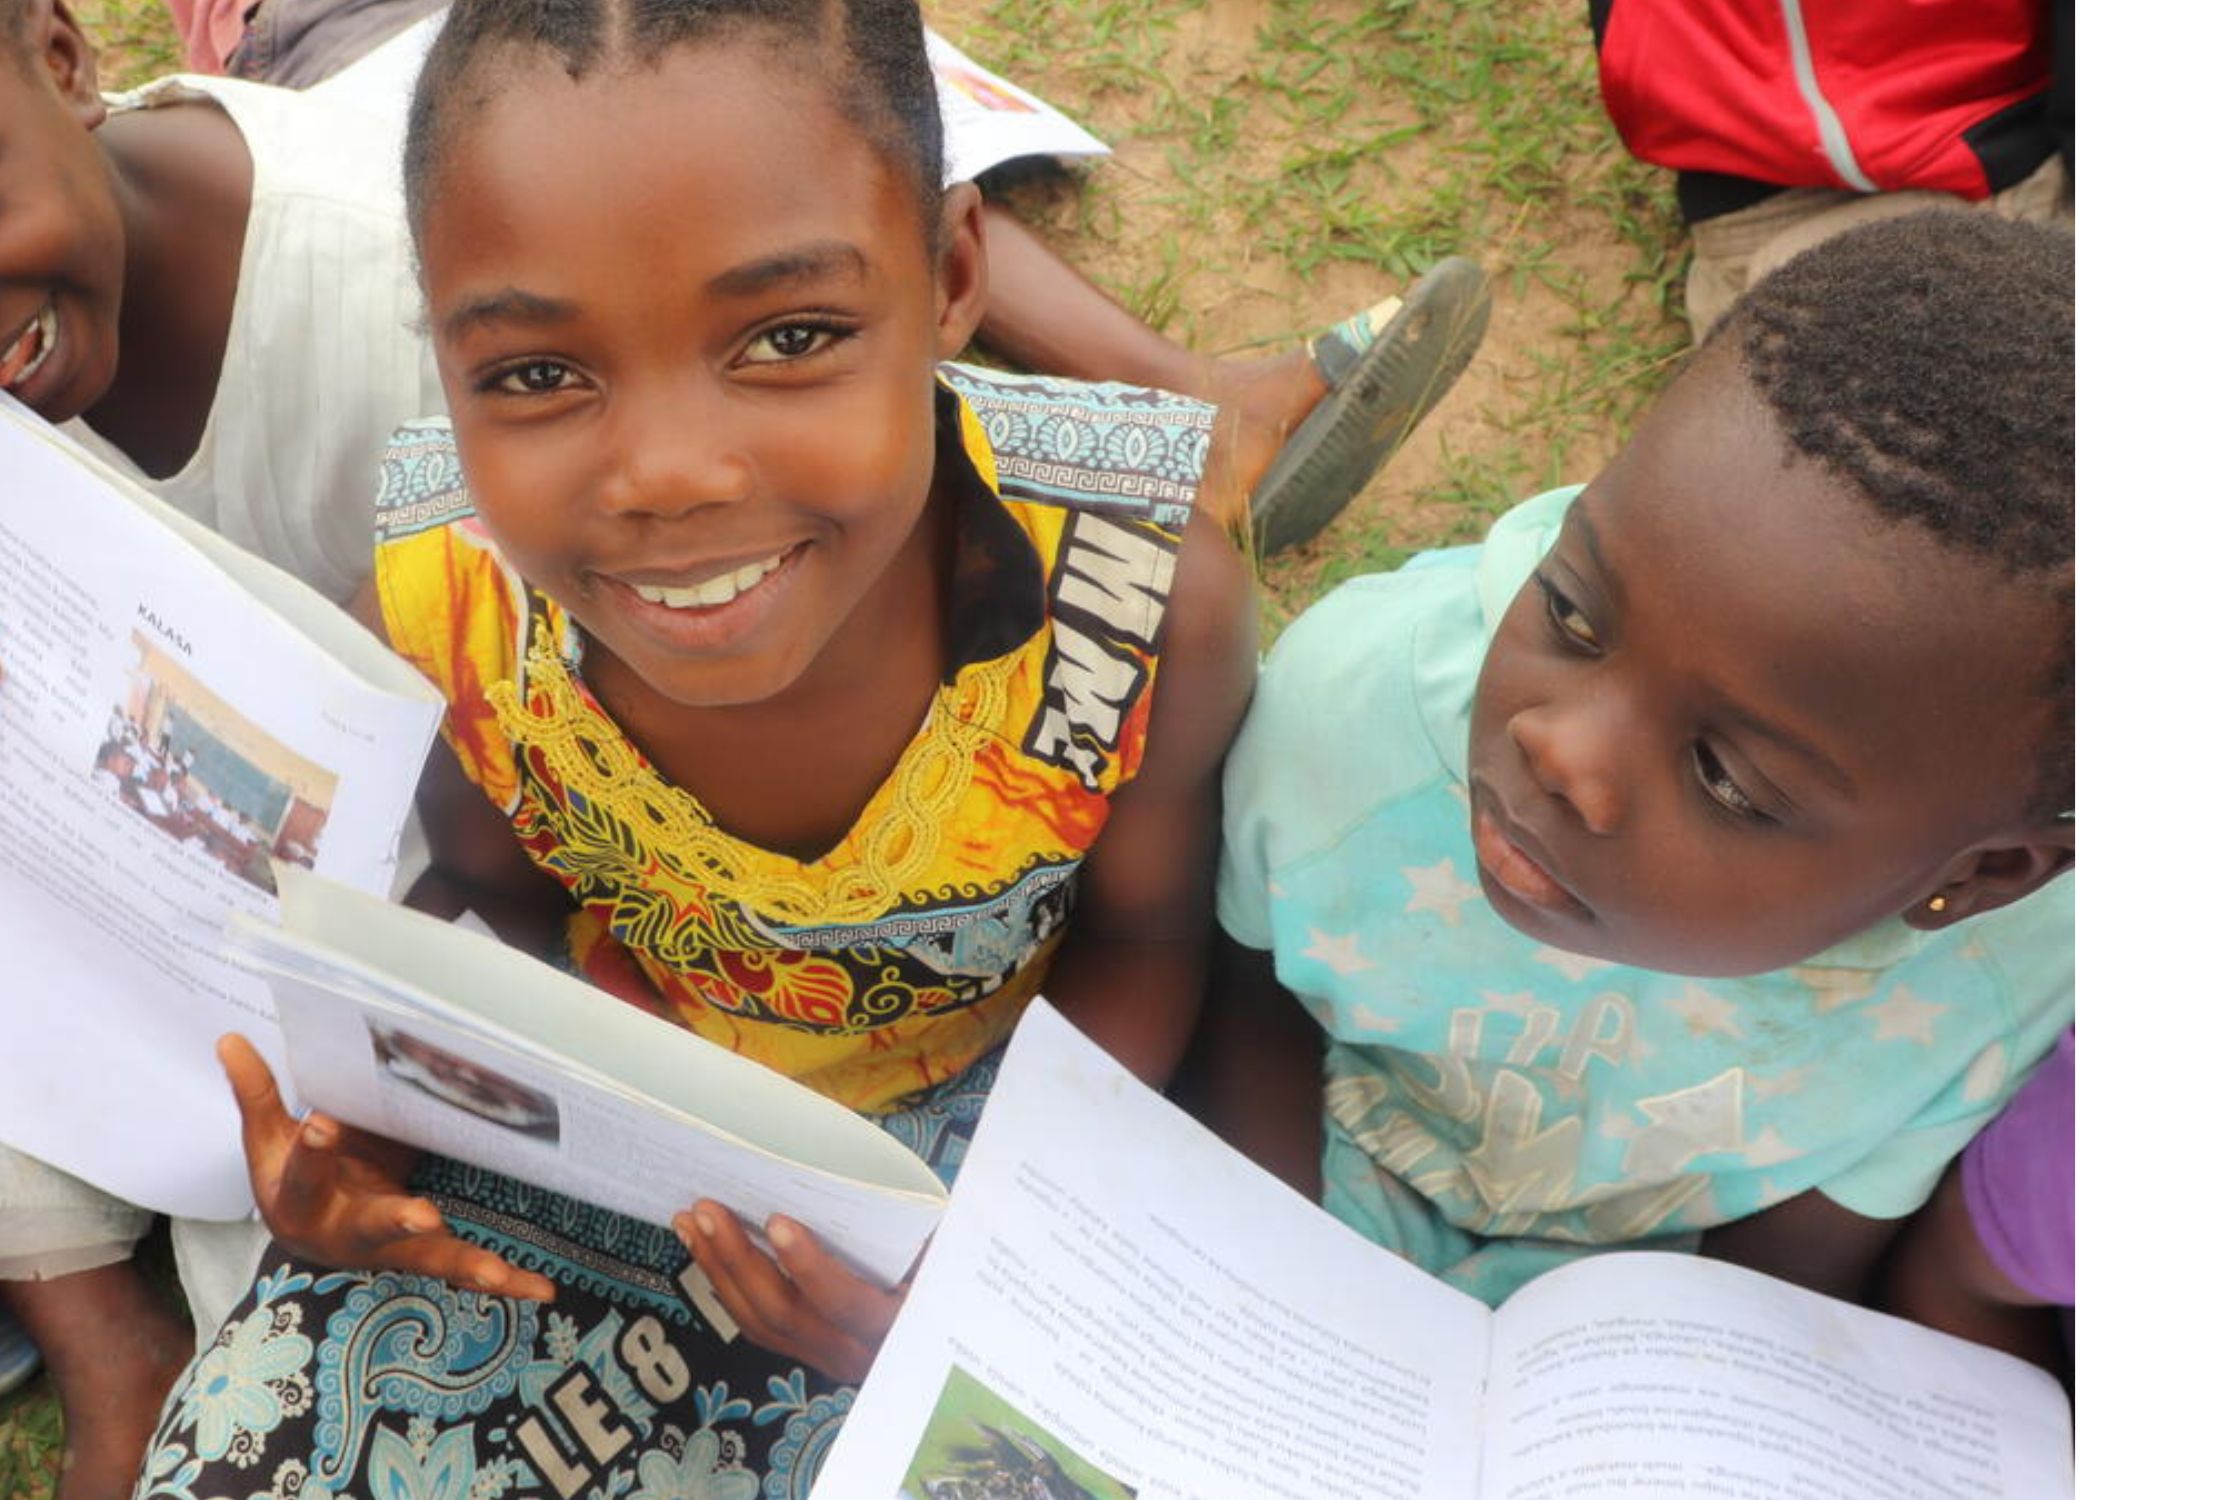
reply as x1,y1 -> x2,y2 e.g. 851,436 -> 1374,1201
404,0 -> 943,238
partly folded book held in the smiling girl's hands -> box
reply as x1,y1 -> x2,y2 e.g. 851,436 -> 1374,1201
234,870 -> 943,1286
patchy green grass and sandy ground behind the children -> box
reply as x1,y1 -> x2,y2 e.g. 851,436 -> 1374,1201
0,0 -> 1687,1500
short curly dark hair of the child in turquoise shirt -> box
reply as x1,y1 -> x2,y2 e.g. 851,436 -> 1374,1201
1709,211 -> 2076,819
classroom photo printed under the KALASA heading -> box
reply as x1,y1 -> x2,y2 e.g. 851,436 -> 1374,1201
93,630 -> 340,895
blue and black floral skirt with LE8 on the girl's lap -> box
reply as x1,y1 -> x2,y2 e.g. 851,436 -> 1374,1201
136,1050 -> 1001,1500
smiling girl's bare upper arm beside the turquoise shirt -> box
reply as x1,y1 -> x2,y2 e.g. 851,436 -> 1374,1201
1044,516 -> 1259,1086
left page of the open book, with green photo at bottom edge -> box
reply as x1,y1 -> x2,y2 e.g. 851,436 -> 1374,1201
812,1001 -> 1491,1500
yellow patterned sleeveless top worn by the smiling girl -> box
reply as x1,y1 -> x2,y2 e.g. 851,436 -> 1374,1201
376,365 -> 1213,1111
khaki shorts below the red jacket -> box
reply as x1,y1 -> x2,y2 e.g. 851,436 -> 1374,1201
1684,156 -> 2074,343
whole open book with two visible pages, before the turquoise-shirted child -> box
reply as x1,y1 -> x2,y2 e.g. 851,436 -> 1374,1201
812,1006 -> 2071,1500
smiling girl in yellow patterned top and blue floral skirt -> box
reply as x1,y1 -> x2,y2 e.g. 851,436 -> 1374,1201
142,0 -> 1255,1500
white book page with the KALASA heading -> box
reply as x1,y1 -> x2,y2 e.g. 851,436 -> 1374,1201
0,403 -> 441,1220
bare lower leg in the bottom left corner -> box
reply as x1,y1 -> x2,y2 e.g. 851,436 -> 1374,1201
0,1260 -> 194,1500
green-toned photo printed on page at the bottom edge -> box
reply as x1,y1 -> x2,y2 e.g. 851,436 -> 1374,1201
901,1364 -> 1135,1500
